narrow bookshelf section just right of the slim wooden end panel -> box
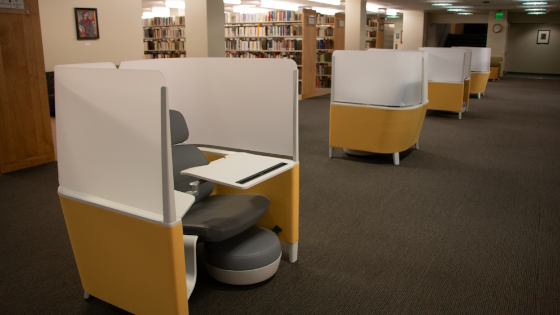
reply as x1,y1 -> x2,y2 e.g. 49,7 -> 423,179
315,13 -> 345,92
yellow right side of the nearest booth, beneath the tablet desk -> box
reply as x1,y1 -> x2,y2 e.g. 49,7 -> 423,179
204,152 -> 299,244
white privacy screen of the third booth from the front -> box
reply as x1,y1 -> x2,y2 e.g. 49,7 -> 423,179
420,47 -> 466,83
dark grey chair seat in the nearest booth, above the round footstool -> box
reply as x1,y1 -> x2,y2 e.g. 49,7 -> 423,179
182,195 -> 270,242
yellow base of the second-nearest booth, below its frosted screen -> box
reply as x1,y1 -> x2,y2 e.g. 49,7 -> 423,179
329,103 -> 428,153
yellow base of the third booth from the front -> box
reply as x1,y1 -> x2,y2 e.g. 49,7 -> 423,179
428,82 -> 465,113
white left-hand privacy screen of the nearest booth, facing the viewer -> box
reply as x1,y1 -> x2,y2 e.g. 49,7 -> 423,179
55,66 -> 165,218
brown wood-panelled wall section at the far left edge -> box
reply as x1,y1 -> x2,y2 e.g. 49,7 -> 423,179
0,0 -> 55,174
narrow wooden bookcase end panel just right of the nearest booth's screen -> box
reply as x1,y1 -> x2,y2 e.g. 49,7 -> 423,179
301,9 -> 317,99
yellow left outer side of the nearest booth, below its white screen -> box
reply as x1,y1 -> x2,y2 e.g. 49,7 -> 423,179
59,196 -> 188,315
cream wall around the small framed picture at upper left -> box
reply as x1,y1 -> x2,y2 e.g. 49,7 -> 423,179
39,0 -> 144,71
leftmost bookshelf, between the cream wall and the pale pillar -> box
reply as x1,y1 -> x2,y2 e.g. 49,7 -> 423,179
142,16 -> 187,59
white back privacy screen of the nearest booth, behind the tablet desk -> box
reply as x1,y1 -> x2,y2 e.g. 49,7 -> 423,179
119,58 -> 298,156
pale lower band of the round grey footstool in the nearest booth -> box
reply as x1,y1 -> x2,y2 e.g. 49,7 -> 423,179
206,254 -> 282,285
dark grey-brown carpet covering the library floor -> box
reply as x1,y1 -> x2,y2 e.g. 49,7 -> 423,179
0,78 -> 560,314
